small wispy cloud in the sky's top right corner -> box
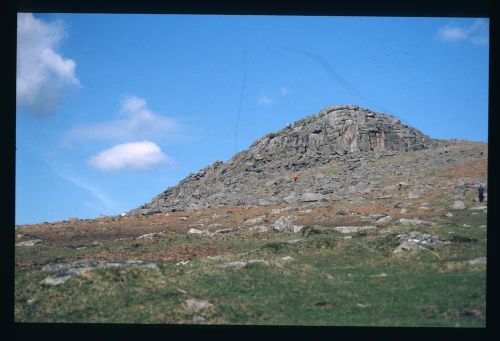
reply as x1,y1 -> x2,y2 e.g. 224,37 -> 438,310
437,19 -> 489,45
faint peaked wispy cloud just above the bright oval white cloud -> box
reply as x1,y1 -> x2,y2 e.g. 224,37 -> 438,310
68,96 -> 180,141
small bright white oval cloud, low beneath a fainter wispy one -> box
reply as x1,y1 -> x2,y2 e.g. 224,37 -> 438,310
87,141 -> 172,171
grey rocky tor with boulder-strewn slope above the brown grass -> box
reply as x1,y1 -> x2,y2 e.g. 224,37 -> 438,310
129,105 -> 472,214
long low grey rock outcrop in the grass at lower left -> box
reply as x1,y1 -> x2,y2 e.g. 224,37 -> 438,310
40,260 -> 158,286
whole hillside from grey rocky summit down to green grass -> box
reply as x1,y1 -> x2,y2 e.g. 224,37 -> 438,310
15,106 -> 488,327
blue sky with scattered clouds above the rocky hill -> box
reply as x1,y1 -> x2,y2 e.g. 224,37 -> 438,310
16,13 -> 489,224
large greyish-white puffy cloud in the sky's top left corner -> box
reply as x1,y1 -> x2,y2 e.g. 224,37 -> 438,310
16,13 -> 80,114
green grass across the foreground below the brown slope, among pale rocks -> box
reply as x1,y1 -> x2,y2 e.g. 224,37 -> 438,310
15,210 -> 486,327
